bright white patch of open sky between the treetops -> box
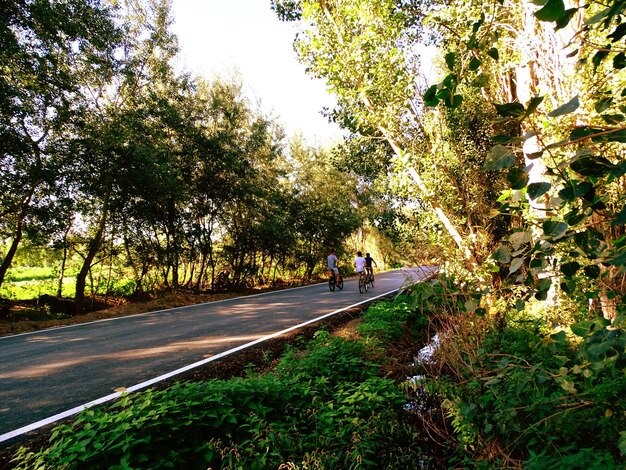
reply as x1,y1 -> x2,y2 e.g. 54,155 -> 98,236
167,0 -> 341,145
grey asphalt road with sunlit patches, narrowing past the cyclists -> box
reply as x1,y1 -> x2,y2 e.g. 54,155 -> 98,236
0,267 -> 433,447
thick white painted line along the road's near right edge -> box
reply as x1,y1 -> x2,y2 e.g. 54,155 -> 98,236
0,289 -> 400,442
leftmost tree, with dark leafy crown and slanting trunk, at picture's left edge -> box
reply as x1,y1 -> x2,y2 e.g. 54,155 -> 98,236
0,0 -> 120,284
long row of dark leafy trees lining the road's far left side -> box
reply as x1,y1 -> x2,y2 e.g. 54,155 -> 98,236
0,0 -> 416,313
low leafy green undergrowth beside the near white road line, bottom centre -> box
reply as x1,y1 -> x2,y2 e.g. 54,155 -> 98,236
14,324 -> 424,469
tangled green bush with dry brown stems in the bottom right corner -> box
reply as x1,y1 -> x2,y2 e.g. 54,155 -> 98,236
429,304 -> 626,469
